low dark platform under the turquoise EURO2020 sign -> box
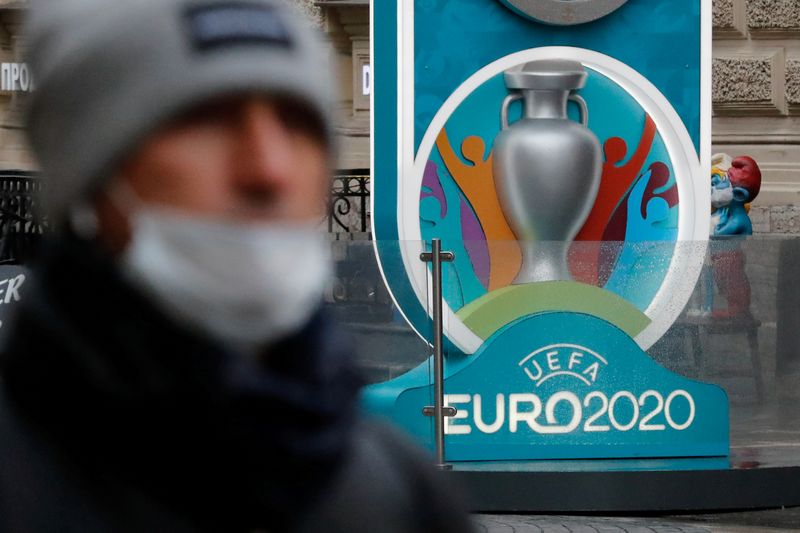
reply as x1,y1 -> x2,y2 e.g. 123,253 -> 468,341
448,446 -> 800,514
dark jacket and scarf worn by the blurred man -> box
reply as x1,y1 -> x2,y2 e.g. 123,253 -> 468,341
0,237 -> 469,533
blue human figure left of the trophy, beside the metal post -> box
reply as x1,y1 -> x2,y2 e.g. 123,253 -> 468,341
419,162 -> 486,311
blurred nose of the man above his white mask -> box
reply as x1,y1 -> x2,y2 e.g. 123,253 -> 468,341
233,99 -> 296,203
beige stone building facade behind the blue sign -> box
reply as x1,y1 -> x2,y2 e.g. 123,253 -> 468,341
0,0 -> 800,234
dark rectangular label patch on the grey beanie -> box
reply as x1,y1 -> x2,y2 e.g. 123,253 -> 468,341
186,2 -> 292,50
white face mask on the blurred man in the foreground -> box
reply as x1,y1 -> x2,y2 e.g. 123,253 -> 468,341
122,204 -> 331,349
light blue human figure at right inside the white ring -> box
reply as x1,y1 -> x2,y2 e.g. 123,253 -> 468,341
605,171 -> 678,311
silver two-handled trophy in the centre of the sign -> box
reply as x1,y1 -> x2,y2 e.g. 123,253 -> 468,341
494,59 -> 603,284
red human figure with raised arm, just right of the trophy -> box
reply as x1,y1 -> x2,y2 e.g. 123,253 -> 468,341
571,115 -> 656,285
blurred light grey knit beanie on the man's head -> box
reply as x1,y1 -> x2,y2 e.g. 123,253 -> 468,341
26,0 -> 332,221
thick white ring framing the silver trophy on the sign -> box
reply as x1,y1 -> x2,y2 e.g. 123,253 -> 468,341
398,46 -> 710,353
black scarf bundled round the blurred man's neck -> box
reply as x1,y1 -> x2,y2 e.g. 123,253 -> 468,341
0,236 -> 361,526
